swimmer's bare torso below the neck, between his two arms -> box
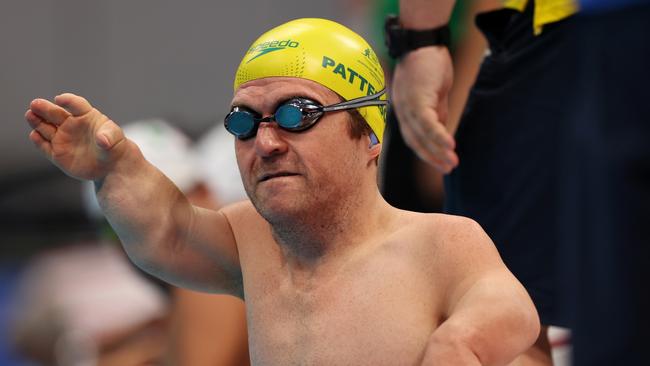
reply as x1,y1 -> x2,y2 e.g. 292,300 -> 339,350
225,204 -> 458,365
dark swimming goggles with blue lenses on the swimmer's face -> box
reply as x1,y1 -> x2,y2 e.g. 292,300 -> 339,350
224,89 -> 388,140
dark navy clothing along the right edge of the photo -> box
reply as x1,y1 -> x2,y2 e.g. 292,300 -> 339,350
557,5 -> 650,366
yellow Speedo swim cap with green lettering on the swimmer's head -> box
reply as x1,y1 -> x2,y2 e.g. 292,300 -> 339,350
234,18 -> 386,142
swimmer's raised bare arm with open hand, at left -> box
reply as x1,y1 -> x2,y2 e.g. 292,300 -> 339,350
25,94 -> 242,296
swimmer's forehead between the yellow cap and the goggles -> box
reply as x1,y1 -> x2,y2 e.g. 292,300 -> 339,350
231,76 -> 340,105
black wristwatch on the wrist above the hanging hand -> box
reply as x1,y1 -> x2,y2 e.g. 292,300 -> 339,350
384,15 -> 449,59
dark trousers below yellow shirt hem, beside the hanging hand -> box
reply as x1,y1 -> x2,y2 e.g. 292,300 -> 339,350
445,6 -> 571,326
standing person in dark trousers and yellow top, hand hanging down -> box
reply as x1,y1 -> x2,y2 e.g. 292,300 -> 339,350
384,0 -> 576,365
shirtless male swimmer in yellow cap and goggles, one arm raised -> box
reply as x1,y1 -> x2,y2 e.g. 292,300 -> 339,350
26,19 -> 539,365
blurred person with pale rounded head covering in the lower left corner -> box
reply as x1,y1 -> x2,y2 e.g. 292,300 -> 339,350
11,242 -> 167,366
